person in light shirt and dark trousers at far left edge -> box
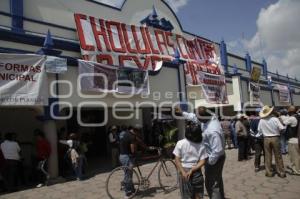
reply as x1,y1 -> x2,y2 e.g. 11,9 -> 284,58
1,133 -> 21,191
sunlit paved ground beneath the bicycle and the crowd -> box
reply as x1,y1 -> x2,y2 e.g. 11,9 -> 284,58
0,149 -> 300,199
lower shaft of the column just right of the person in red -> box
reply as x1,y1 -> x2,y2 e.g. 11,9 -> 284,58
43,120 -> 58,178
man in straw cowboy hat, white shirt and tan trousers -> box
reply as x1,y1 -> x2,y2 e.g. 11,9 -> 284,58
258,106 -> 286,178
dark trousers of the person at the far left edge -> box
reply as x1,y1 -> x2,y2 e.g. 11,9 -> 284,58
3,159 -> 19,191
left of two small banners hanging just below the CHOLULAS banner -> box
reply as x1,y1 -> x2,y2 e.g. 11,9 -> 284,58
78,60 -> 117,92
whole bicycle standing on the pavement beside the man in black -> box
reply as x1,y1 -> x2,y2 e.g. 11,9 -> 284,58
106,147 -> 178,199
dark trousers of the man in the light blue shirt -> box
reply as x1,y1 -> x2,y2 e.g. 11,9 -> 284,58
205,154 -> 226,199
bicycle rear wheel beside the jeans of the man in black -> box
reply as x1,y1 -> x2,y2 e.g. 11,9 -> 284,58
105,166 -> 140,199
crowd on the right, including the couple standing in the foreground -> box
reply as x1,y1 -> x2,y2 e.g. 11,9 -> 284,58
173,106 -> 300,199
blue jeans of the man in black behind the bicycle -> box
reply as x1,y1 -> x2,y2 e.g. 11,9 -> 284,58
119,154 -> 135,195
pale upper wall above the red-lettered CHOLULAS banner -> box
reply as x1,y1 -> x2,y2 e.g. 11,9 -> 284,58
24,0 -> 180,41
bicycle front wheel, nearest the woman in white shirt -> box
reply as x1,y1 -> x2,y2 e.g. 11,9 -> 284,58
158,160 -> 178,192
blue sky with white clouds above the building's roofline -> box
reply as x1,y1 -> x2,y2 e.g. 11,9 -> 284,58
92,0 -> 300,79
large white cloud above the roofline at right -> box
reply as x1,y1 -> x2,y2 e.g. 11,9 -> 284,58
228,0 -> 300,77
